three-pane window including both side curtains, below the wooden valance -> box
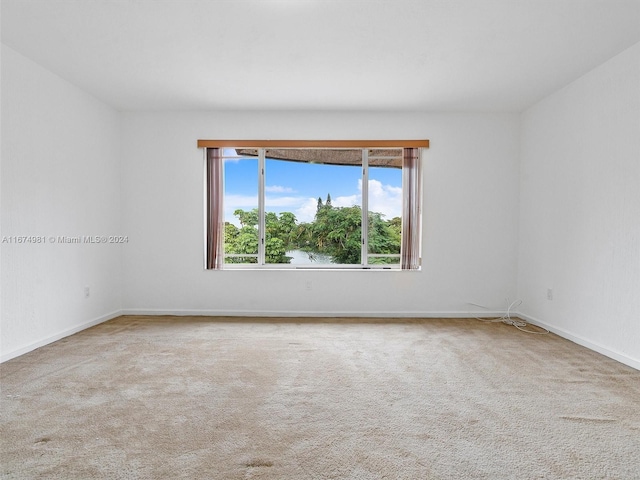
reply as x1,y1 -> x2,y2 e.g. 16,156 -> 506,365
199,141 -> 428,270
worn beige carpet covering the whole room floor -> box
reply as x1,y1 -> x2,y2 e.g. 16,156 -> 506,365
0,317 -> 640,479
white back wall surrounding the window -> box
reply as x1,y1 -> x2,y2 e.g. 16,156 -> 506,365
122,112 -> 519,316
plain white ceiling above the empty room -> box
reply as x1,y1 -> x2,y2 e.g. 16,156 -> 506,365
1,0 -> 640,112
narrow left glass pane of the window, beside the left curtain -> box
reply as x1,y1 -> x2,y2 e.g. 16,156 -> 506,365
223,149 -> 259,263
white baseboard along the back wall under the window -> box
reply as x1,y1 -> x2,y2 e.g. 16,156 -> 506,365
122,308 -> 504,318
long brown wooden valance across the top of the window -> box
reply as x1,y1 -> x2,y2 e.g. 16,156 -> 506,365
198,140 -> 429,148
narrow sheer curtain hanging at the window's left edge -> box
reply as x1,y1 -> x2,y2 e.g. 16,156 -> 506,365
207,148 -> 224,270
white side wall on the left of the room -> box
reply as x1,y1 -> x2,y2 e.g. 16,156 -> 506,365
0,45 -> 122,360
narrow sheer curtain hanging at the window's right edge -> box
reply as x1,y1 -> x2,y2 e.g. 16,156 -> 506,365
400,148 -> 422,270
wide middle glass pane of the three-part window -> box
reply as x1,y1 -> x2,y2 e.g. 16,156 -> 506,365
265,149 -> 362,264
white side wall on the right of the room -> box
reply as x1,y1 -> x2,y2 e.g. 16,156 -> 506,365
518,44 -> 640,368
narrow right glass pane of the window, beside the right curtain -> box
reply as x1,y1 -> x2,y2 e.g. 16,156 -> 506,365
367,149 -> 402,265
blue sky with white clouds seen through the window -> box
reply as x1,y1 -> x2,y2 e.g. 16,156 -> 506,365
224,152 -> 402,225
